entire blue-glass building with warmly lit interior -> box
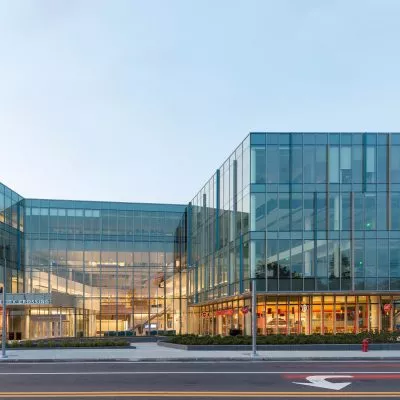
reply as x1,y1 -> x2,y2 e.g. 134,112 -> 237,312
0,133 -> 400,339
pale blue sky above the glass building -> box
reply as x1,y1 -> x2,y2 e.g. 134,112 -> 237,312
0,0 -> 400,203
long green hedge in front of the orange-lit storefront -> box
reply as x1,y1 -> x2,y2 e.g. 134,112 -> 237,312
168,332 -> 400,345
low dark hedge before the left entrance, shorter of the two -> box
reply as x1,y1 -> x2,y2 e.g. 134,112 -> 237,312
7,339 -> 129,348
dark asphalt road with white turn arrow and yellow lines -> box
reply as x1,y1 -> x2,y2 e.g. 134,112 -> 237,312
0,361 -> 400,399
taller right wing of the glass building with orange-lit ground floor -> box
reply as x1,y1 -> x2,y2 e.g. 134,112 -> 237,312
188,133 -> 400,334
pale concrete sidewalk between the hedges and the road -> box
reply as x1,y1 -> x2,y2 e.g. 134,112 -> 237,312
0,343 -> 400,362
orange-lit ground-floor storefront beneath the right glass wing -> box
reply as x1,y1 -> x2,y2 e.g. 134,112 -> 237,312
192,295 -> 400,335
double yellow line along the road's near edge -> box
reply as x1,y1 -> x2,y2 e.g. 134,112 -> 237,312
0,391 -> 400,399
